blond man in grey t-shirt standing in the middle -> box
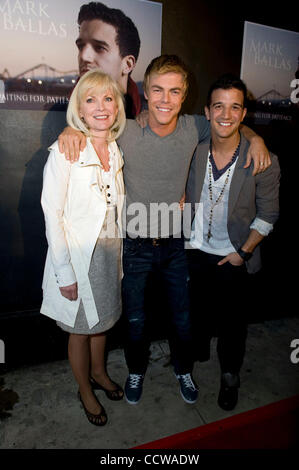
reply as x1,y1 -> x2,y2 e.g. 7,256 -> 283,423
59,55 -> 267,410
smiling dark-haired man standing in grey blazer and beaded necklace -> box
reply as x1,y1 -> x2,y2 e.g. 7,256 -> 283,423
186,74 -> 280,410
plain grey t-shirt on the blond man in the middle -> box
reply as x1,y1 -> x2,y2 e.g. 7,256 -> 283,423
118,115 -> 210,237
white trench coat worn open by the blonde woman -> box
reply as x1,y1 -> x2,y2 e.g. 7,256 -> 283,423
40,139 -> 124,328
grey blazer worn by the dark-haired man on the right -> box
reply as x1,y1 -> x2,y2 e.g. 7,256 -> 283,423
186,135 -> 280,273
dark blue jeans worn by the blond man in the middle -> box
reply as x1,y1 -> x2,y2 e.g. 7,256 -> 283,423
122,238 -> 193,374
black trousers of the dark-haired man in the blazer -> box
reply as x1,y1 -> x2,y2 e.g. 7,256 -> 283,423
186,249 -> 248,374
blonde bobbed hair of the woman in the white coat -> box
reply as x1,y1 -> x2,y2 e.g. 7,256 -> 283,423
66,69 -> 126,142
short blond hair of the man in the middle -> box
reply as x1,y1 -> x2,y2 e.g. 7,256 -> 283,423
143,54 -> 188,98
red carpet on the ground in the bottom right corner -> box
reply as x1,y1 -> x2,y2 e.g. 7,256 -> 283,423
134,395 -> 299,449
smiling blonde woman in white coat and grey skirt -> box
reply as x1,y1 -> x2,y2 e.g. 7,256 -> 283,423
41,70 -> 125,426
